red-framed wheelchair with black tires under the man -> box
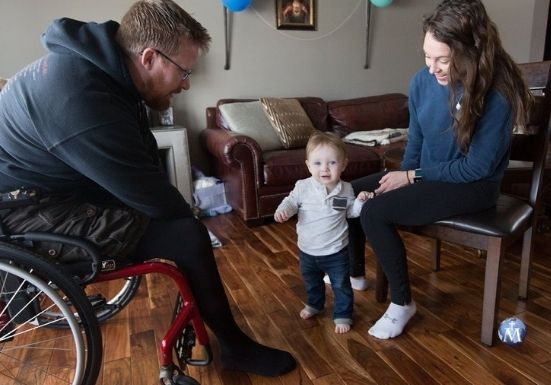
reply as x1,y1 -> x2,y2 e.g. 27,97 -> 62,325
0,210 -> 212,385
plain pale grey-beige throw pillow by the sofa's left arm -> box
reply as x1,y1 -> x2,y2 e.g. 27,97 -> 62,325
220,101 -> 283,151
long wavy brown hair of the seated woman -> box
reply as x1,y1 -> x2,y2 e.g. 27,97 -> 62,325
423,0 -> 532,151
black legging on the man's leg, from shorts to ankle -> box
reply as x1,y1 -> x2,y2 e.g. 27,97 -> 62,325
132,217 -> 243,345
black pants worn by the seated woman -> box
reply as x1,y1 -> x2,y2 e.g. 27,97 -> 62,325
349,172 -> 499,305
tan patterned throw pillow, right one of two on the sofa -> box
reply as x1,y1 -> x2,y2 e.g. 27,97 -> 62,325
260,98 -> 315,149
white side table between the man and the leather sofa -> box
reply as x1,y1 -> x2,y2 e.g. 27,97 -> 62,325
151,126 -> 193,205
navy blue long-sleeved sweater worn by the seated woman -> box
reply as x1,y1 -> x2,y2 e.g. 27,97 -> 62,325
401,68 -> 513,183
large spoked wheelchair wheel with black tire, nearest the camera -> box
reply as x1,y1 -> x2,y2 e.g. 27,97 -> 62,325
0,243 -> 102,385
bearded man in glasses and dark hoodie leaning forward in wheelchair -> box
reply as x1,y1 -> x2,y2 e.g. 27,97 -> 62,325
0,0 -> 296,376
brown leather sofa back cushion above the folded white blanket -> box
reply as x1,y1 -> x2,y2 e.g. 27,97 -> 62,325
327,94 -> 409,136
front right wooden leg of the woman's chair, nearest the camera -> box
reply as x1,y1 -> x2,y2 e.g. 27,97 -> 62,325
480,238 -> 503,346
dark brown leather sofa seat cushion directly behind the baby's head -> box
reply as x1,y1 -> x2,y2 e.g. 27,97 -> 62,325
263,144 -> 382,186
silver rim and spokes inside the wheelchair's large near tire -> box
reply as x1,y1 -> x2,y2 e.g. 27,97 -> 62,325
0,262 -> 86,385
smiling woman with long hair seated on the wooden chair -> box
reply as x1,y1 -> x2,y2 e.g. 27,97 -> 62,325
349,0 -> 531,339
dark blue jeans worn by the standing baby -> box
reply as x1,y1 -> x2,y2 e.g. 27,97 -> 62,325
299,247 -> 354,320
